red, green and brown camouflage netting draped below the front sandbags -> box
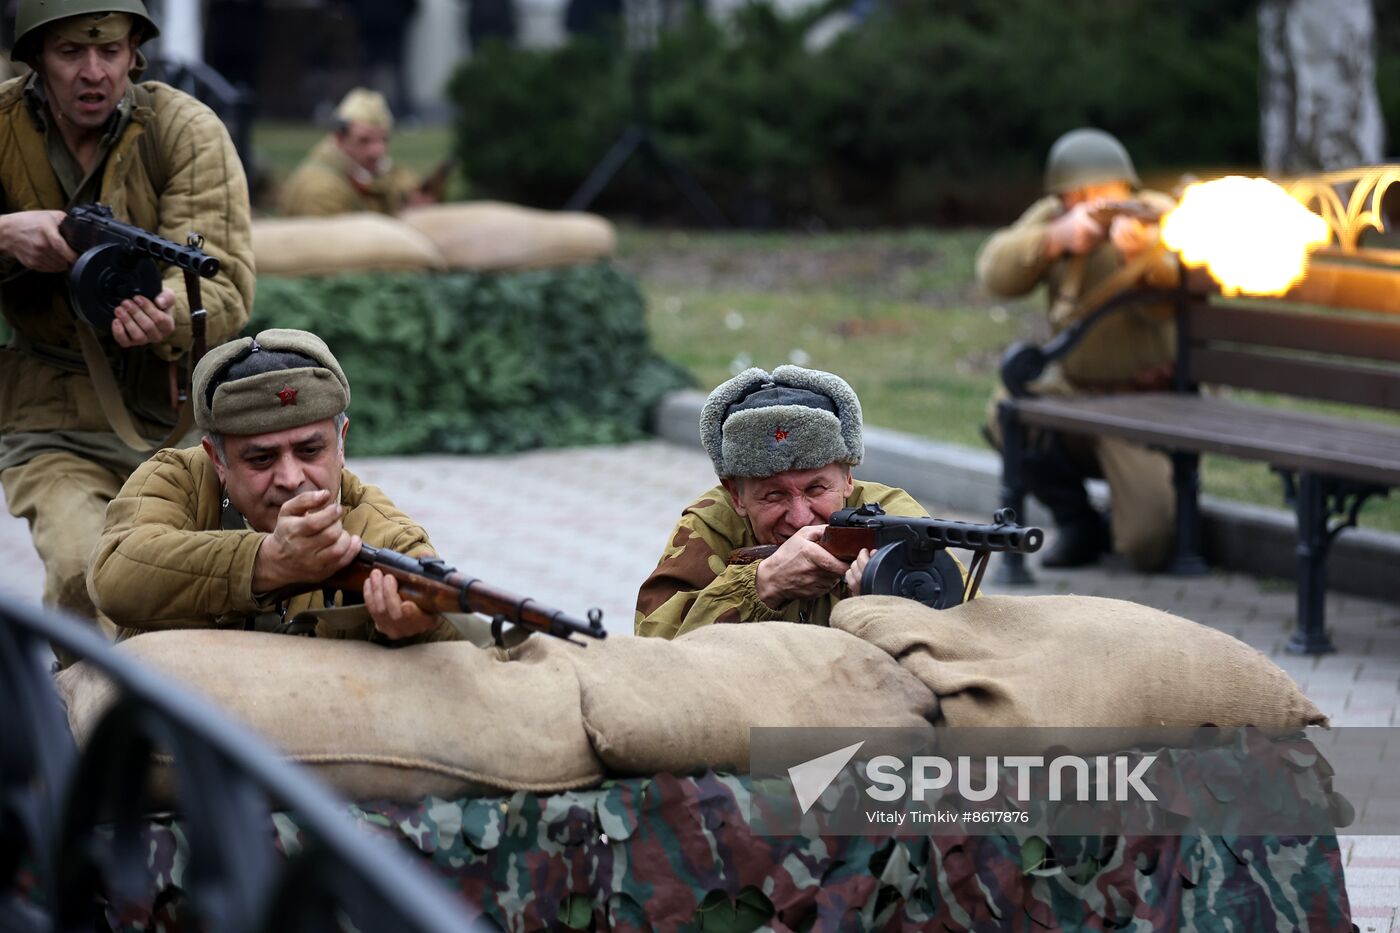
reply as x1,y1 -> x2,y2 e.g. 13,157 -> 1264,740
101,772 -> 1350,932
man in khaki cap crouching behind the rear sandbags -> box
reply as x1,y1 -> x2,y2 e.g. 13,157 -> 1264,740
281,87 -> 431,217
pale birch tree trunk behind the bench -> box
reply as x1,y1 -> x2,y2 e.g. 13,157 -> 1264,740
1259,0 -> 1385,174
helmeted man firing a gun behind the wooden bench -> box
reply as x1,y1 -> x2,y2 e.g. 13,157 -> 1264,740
977,129 -> 1176,570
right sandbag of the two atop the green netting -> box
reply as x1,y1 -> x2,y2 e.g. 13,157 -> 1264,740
399,200 -> 617,270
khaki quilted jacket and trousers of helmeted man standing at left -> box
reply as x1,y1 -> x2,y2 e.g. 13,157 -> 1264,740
0,78 -> 253,647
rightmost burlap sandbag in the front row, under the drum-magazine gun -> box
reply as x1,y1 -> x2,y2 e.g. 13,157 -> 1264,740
834,595 -> 1327,730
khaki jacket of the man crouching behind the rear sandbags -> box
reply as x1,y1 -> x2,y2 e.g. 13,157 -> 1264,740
280,136 -> 420,217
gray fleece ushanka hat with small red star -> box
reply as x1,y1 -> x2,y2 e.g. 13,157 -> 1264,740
700,366 -> 865,479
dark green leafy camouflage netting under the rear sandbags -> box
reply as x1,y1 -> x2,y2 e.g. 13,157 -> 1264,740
253,263 -> 687,457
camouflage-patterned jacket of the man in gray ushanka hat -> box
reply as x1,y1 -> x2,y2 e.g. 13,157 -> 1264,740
636,481 -> 946,639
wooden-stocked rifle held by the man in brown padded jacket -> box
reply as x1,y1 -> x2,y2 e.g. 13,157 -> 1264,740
321,545 -> 608,646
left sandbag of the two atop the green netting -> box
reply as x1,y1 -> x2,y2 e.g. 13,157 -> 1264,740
253,213 -> 447,276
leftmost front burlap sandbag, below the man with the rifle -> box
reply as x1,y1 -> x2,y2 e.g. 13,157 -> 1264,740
57,629 -> 602,800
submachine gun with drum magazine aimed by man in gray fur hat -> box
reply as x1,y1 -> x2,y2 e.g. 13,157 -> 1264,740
729,503 -> 1044,609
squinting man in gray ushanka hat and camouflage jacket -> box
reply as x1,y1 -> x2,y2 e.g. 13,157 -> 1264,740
636,366 -> 963,639
